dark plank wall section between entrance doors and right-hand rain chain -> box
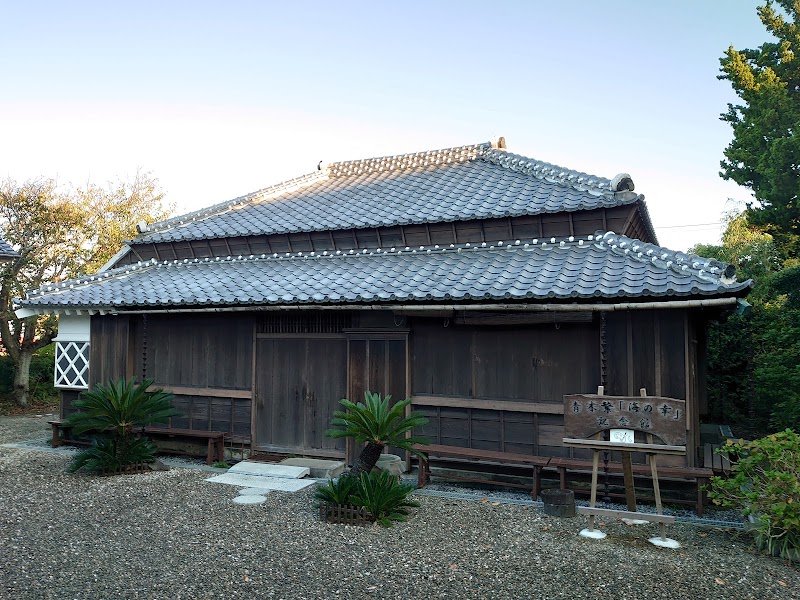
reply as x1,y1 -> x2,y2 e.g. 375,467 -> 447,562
411,318 -> 600,456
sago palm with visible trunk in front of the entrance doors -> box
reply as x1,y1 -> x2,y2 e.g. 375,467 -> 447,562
325,392 -> 428,479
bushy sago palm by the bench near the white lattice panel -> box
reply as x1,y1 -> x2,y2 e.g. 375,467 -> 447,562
64,378 -> 179,472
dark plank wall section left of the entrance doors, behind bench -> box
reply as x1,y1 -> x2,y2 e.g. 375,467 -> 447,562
83,313 -> 254,437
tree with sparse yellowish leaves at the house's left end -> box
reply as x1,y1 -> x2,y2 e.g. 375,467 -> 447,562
0,173 -> 169,407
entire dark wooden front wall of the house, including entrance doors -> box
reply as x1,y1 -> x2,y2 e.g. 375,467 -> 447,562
81,310 -> 706,464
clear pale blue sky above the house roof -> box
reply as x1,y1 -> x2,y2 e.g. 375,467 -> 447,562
0,0 -> 767,250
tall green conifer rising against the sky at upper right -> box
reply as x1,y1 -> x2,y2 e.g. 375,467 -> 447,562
719,0 -> 800,258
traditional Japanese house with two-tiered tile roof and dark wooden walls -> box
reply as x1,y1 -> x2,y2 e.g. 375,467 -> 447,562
20,138 -> 751,465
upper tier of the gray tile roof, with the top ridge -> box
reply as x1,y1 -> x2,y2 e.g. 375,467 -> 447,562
133,142 -> 655,244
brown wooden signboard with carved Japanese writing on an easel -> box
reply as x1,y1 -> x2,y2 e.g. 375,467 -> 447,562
564,394 -> 686,446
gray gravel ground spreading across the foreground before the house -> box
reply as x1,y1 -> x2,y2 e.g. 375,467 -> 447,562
0,417 -> 800,600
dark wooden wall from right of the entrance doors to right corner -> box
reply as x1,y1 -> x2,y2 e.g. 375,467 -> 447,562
411,310 -> 704,465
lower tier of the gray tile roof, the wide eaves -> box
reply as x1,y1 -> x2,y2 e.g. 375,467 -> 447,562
20,232 -> 751,309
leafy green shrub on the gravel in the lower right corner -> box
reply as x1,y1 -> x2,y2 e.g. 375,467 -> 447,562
709,429 -> 800,560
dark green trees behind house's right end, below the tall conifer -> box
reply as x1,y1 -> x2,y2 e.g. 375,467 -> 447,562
691,211 -> 800,436
